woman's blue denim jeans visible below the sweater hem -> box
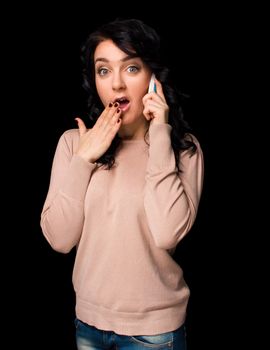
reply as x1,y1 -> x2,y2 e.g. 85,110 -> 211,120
75,319 -> 186,350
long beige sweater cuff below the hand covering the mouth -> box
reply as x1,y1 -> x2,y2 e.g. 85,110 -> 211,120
62,155 -> 96,201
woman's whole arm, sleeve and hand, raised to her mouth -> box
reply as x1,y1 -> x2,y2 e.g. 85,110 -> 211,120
41,103 -> 121,253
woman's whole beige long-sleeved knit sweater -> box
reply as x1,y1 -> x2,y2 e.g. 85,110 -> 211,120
41,124 -> 203,335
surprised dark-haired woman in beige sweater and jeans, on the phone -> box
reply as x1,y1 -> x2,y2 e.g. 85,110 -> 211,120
41,19 -> 203,350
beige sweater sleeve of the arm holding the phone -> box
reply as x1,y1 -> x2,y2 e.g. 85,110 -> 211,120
144,124 -> 204,250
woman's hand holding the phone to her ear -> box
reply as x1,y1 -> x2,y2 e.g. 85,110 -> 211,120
142,79 -> 169,124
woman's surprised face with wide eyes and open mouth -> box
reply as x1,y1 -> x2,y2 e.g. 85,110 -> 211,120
94,40 -> 151,133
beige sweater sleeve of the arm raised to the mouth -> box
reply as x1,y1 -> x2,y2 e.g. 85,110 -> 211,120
41,130 -> 96,253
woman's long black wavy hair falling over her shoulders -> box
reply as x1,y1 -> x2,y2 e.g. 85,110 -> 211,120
81,19 -> 196,171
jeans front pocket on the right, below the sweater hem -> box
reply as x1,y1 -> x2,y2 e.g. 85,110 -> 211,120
131,332 -> 173,348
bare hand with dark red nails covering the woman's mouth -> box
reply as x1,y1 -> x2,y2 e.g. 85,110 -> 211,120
75,102 -> 122,163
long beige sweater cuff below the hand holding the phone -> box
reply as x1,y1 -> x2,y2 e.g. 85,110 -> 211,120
149,124 -> 175,169
